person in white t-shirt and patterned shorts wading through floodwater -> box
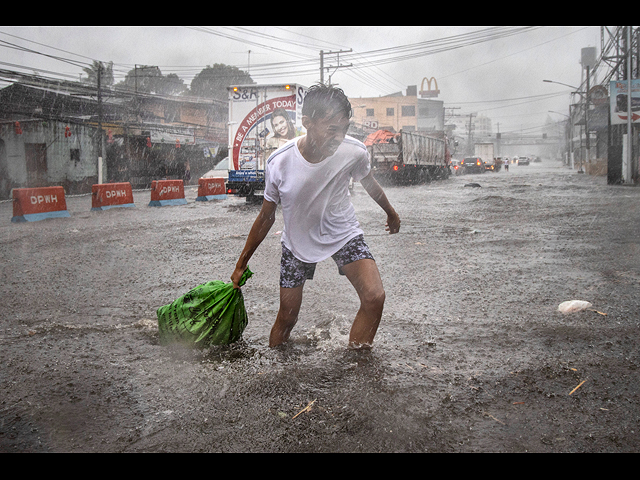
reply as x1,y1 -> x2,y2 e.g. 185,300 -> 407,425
231,85 -> 400,348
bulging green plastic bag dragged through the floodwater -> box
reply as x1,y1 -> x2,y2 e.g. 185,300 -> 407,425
156,269 -> 253,347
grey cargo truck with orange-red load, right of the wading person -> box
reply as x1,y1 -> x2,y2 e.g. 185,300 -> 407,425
364,130 -> 451,184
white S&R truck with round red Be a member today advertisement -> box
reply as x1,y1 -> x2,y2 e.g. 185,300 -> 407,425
225,83 -> 307,202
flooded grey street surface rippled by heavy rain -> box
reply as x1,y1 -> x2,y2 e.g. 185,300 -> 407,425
0,161 -> 640,452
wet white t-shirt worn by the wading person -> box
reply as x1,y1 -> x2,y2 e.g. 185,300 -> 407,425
264,136 -> 371,263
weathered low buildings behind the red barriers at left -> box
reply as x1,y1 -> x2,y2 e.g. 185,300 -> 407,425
0,83 -> 227,199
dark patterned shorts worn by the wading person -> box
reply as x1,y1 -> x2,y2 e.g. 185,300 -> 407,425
280,235 -> 374,288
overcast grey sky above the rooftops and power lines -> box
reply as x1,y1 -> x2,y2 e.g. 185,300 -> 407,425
0,26 -> 600,133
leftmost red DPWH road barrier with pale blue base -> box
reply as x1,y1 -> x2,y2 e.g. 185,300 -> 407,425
11,187 -> 70,222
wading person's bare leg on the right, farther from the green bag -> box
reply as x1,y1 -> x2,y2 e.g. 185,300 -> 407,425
342,259 -> 385,348
